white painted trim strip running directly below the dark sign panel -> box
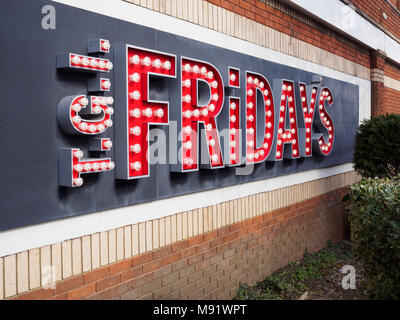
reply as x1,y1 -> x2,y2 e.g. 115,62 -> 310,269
0,163 -> 353,257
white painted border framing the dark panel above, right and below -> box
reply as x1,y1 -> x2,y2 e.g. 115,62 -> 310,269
0,0 -> 371,257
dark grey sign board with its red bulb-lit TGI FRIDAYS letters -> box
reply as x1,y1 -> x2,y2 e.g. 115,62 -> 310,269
0,0 -> 359,231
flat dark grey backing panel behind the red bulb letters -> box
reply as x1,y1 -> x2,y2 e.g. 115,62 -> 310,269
0,0 -> 359,230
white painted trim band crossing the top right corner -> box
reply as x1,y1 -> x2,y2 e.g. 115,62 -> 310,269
286,0 -> 400,63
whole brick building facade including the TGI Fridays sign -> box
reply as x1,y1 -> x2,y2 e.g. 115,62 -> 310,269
0,0 -> 400,299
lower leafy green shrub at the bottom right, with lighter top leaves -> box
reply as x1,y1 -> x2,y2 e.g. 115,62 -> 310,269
348,176 -> 400,299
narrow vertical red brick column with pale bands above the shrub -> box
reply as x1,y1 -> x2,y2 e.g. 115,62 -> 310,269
371,50 -> 386,117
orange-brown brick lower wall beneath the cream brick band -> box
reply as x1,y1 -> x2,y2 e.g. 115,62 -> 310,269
13,188 -> 347,299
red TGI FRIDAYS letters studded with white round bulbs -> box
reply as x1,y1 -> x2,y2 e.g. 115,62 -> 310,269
57,39 -> 335,187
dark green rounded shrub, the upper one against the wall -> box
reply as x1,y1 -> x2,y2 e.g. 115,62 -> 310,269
354,114 -> 400,178
